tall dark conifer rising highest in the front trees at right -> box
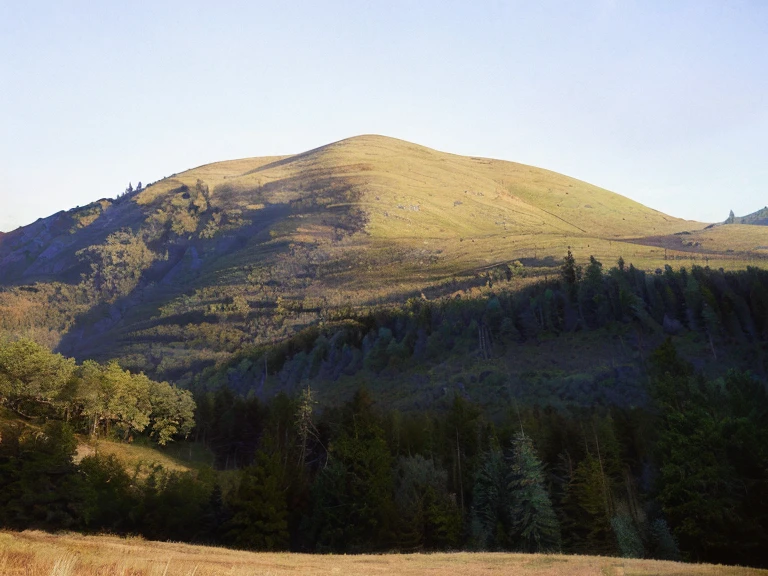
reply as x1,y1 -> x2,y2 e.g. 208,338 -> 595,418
651,341 -> 744,561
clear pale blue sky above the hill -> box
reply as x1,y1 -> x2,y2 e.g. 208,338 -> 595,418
0,0 -> 768,231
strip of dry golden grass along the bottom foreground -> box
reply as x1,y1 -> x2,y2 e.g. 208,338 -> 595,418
0,531 -> 768,576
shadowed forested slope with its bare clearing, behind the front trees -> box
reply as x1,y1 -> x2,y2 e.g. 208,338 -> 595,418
200,251 -> 768,411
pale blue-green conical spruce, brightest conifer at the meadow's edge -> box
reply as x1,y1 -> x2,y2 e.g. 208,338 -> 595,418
508,434 -> 560,553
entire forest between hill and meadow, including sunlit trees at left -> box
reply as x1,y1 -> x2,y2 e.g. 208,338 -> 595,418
0,252 -> 768,566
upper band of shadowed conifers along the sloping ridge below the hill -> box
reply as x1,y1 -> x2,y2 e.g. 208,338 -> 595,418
201,251 -> 768,403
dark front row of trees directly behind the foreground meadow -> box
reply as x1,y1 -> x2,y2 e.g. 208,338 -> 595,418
0,342 -> 768,566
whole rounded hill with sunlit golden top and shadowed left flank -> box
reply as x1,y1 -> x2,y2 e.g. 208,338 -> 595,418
0,136 -> 768,382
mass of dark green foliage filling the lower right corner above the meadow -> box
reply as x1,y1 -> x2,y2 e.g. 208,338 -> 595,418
653,342 -> 768,561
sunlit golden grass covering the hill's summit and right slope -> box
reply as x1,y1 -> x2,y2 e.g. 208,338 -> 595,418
137,135 -> 768,294
